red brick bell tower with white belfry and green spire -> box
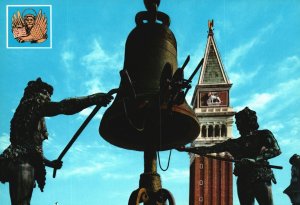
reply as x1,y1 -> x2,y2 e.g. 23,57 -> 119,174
189,20 -> 235,205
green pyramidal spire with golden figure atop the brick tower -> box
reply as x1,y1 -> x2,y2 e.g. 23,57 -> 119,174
198,20 -> 231,85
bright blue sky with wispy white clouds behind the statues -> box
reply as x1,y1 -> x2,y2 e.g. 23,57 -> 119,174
0,0 -> 300,205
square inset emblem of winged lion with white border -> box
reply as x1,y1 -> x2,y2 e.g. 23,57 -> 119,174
7,5 -> 52,48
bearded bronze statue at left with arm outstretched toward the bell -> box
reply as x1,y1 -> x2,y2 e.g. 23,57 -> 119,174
0,78 -> 112,205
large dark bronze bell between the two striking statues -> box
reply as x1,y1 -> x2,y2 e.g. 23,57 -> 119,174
99,7 -> 200,151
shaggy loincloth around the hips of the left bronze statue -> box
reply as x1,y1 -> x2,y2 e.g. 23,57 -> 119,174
0,145 -> 46,191
